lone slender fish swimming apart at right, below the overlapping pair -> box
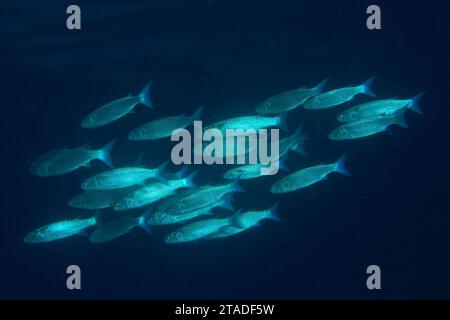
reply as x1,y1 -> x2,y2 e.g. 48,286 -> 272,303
270,155 -> 350,194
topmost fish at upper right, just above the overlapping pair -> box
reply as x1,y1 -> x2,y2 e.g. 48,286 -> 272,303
304,78 -> 375,110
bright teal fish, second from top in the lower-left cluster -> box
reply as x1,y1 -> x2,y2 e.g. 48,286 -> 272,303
113,172 -> 197,211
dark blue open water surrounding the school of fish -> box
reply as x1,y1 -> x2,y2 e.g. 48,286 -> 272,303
0,0 -> 450,299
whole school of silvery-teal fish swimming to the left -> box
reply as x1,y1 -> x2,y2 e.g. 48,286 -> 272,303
24,78 -> 424,244
